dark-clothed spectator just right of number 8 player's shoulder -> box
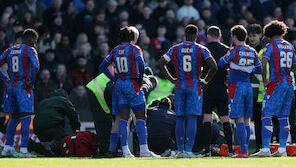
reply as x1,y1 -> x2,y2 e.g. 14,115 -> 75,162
41,49 -> 57,73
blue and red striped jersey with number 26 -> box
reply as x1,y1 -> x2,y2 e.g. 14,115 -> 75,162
262,39 -> 296,85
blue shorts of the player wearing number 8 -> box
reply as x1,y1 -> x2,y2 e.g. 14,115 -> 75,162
3,88 -> 34,114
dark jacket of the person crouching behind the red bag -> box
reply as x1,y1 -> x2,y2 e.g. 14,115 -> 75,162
34,89 -> 80,132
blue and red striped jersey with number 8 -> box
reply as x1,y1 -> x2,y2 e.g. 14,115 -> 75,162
0,44 -> 39,88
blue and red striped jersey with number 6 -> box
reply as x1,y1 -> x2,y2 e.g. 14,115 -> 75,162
163,41 -> 211,89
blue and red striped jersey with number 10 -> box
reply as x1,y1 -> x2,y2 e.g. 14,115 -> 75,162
105,43 -> 144,80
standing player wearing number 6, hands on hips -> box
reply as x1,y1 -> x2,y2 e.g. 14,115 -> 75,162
158,24 -> 217,158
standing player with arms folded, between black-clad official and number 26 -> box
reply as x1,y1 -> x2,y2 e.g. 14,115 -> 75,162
218,25 -> 262,158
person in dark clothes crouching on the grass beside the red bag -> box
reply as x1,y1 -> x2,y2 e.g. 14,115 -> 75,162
33,89 -> 80,154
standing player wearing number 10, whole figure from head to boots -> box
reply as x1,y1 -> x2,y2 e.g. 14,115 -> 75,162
100,27 -> 159,157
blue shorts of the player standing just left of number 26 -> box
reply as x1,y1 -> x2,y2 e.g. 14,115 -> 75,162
228,82 -> 253,118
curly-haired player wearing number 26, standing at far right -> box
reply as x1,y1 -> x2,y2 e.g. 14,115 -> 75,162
253,21 -> 296,157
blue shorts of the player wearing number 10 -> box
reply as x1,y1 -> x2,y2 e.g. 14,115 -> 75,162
115,79 -> 146,112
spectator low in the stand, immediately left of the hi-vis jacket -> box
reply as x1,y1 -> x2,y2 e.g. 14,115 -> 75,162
69,85 -> 90,111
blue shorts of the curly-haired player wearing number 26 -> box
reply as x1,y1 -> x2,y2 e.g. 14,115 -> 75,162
262,81 -> 294,116
